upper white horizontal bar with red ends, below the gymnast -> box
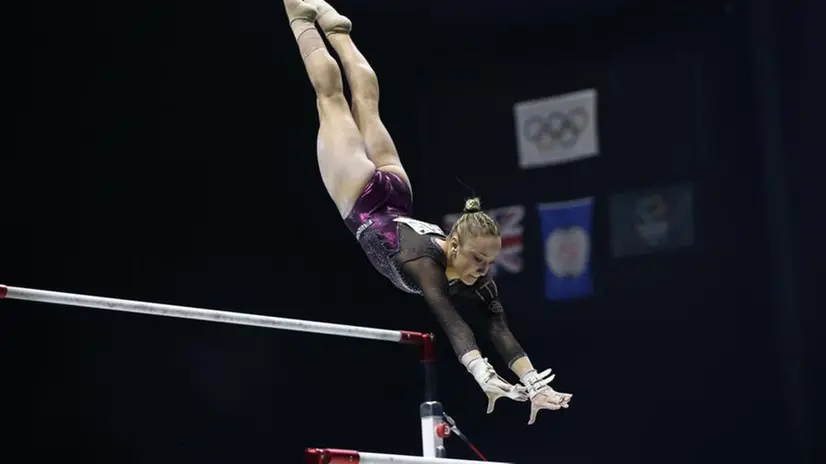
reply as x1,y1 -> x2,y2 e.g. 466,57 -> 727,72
0,285 -> 424,344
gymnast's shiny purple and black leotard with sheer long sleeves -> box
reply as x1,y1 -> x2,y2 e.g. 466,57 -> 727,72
345,169 -> 525,363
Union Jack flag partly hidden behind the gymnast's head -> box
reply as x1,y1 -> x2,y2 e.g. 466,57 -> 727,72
442,205 -> 525,277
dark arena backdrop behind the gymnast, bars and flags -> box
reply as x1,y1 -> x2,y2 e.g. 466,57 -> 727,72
0,0 -> 826,464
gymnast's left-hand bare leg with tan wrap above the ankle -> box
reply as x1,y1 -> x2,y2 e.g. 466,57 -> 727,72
284,0 -> 375,217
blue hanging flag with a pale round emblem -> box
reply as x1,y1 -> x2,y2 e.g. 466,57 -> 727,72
537,197 -> 594,301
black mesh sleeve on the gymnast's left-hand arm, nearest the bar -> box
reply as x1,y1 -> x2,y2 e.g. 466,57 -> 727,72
404,257 -> 479,358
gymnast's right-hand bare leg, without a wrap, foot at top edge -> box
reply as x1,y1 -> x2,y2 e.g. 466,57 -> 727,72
305,0 -> 412,194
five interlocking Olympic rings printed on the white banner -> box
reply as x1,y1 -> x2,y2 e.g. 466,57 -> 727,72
522,107 -> 591,151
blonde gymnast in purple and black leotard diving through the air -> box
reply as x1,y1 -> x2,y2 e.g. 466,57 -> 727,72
284,0 -> 572,424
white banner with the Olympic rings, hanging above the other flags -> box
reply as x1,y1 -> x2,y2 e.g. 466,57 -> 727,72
513,89 -> 599,169
